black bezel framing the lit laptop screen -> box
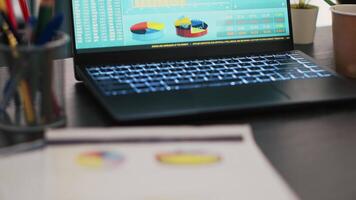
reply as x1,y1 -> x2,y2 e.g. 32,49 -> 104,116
70,0 -> 294,66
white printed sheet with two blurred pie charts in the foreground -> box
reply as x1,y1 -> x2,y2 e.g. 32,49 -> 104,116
45,126 -> 297,200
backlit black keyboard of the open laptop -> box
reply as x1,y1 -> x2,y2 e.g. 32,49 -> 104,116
86,52 -> 332,96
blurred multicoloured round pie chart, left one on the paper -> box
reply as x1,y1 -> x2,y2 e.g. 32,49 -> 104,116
76,151 -> 124,169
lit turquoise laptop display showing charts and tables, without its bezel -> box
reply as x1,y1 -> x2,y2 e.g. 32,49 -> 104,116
72,0 -> 290,53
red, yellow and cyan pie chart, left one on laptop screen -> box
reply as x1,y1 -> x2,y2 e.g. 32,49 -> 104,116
130,22 -> 165,41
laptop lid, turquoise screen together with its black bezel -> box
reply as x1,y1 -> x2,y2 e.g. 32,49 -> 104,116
71,0 -> 293,64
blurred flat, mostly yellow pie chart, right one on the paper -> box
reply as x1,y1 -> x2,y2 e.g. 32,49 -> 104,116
156,151 -> 221,166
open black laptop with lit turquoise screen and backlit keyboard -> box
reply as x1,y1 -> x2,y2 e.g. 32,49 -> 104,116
71,0 -> 356,122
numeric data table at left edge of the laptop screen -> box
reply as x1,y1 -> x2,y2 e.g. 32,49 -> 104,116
73,0 -> 124,48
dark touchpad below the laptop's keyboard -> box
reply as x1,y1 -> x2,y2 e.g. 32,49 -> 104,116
193,85 -> 289,110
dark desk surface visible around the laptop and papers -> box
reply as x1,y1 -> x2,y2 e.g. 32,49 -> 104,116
0,27 -> 356,200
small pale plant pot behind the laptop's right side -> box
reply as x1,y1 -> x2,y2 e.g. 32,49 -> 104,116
291,7 -> 319,44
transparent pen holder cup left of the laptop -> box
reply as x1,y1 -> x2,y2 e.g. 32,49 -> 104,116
0,32 -> 69,133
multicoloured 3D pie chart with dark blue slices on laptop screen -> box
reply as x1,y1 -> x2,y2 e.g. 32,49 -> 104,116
174,17 -> 208,38
